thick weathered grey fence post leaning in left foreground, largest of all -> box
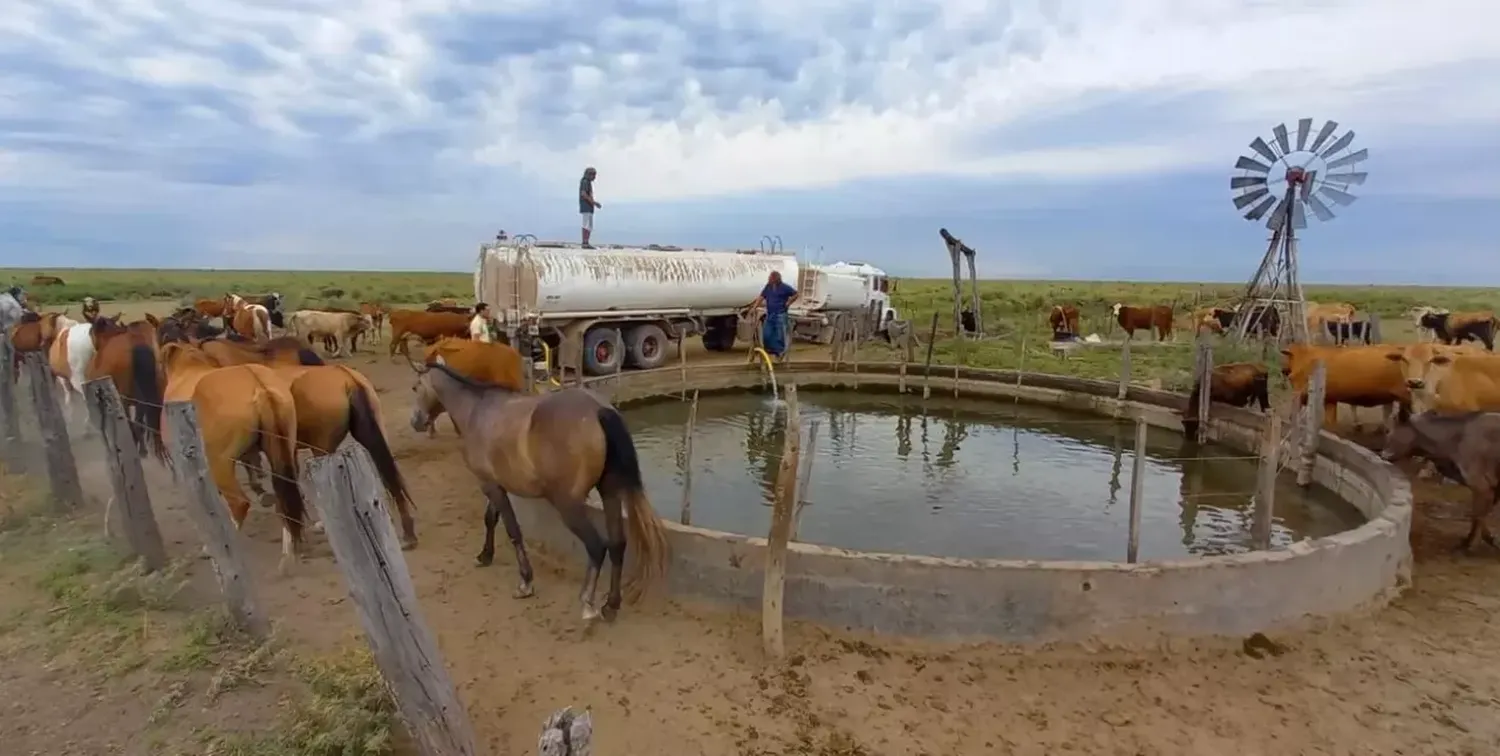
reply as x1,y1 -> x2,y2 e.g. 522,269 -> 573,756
308,444 -> 479,756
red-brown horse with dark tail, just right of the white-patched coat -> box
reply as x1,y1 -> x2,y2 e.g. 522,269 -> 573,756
84,318 -> 167,456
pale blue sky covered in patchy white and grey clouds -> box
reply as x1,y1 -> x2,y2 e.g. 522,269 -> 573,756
0,0 -> 1500,285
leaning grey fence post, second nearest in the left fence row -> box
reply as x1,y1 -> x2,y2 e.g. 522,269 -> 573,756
167,402 -> 272,639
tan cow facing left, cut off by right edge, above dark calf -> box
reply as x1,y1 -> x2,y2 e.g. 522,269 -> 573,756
1386,344 -> 1500,413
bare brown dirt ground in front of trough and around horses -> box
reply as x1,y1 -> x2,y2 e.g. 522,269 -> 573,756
0,322 -> 1500,756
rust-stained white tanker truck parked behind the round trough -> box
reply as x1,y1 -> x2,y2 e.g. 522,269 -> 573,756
474,237 -> 888,375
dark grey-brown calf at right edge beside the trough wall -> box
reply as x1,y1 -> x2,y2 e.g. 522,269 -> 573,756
1380,411 -> 1500,552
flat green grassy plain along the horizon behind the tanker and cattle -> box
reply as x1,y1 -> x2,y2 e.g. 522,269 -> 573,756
0,269 -> 1500,389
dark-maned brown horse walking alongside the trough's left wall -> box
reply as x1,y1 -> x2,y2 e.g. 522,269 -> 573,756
411,365 -> 668,621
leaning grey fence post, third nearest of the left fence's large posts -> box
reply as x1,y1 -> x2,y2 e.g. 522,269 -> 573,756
84,378 -> 167,573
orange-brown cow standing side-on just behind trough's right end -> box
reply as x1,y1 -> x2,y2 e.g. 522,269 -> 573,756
1281,344 -> 1412,428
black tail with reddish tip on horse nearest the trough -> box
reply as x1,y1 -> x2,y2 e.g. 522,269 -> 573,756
599,407 -> 671,602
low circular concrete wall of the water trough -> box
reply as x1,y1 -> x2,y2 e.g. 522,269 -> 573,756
516,362 -> 1412,644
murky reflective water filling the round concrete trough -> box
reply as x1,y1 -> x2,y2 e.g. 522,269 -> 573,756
626,392 -> 1361,560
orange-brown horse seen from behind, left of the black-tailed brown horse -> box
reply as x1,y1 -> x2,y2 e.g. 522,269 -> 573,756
158,342 -> 308,575
